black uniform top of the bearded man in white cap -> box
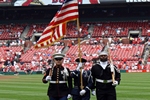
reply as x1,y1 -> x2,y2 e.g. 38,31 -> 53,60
91,64 -> 121,89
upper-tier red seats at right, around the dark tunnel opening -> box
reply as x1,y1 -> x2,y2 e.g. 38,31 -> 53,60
91,20 -> 150,38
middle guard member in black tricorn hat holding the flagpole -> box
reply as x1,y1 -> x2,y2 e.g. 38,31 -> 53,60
71,58 -> 93,100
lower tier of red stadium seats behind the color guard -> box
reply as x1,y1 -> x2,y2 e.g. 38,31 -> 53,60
1,36 -> 147,72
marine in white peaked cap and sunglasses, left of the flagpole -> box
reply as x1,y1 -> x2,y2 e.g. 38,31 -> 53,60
42,53 -> 72,100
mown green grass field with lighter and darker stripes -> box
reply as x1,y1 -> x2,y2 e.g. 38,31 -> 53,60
0,73 -> 150,100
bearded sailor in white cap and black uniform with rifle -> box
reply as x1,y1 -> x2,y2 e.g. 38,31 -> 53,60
91,51 -> 121,100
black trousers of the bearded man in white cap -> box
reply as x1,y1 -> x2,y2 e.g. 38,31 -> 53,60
96,87 -> 116,100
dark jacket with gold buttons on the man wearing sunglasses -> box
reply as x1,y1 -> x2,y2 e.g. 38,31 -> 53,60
42,66 -> 72,97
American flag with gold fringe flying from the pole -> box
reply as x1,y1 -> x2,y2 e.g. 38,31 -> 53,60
35,0 -> 79,48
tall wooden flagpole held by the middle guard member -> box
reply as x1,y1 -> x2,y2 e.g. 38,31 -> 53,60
77,18 -> 83,90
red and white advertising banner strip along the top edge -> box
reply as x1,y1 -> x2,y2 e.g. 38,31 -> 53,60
14,0 -> 150,6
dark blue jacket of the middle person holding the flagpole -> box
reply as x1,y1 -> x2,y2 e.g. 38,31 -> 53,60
71,70 -> 93,95
